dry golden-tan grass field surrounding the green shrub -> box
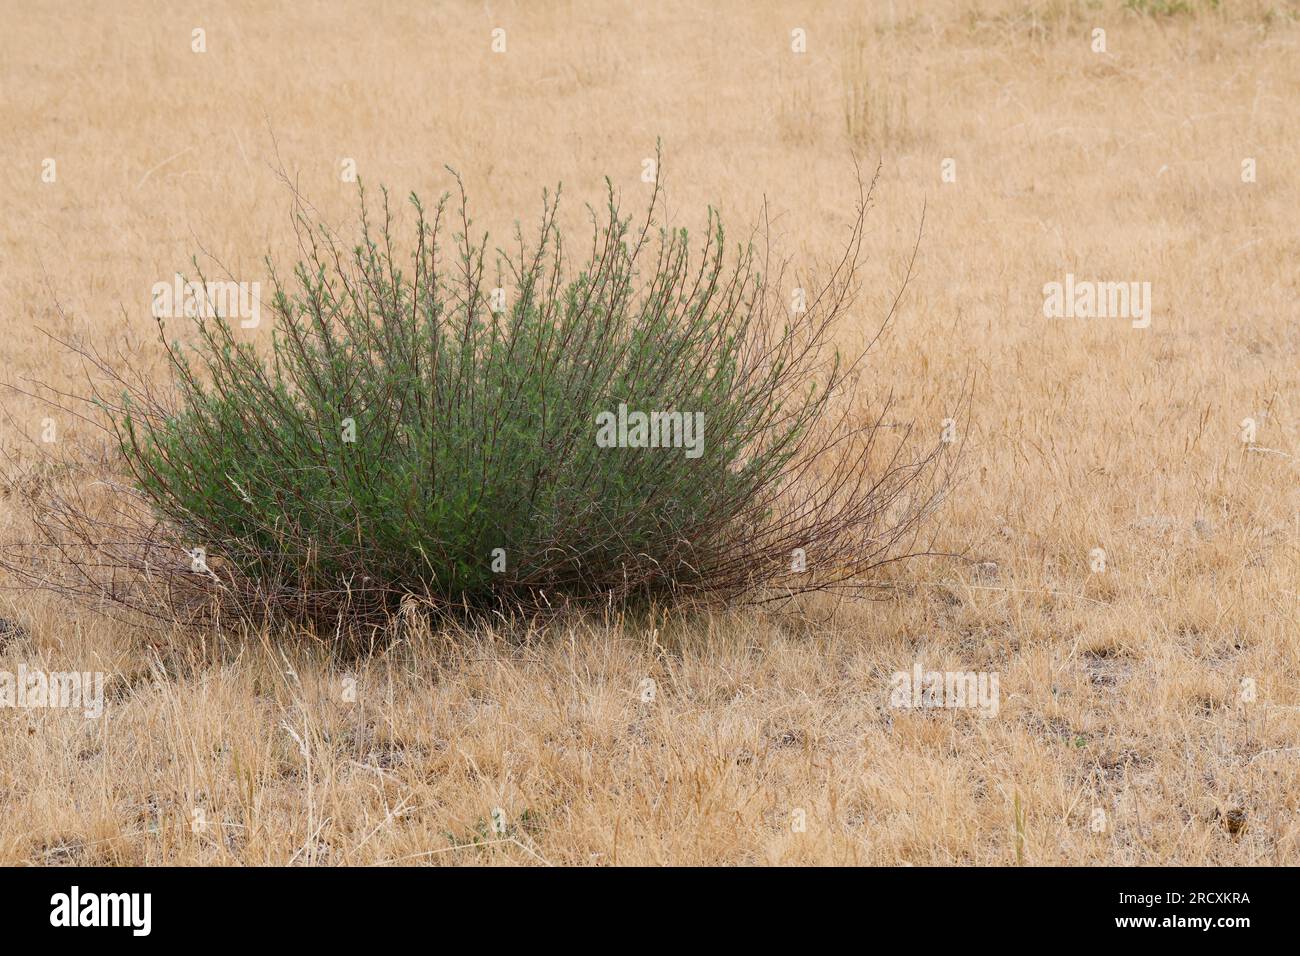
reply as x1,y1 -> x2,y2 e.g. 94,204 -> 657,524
0,0 -> 1300,865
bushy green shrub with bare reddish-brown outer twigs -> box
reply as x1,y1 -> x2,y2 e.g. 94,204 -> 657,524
2,162 -> 953,624
